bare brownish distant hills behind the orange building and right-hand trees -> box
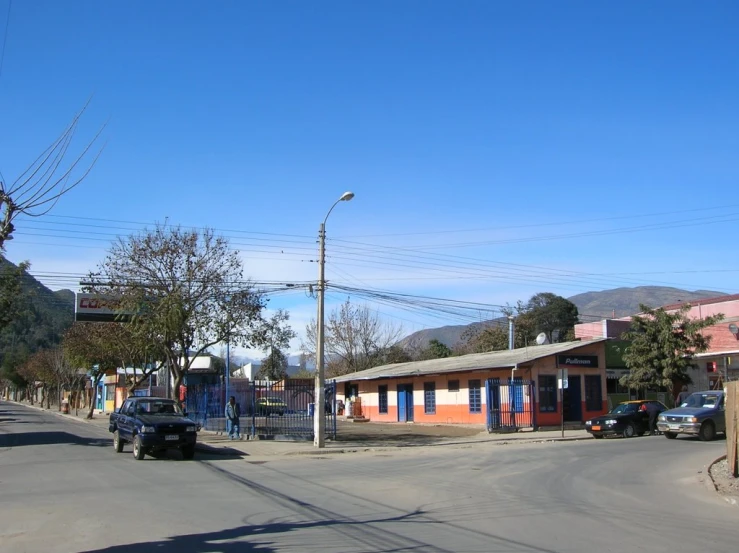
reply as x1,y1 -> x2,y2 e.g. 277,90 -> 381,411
401,286 -> 726,347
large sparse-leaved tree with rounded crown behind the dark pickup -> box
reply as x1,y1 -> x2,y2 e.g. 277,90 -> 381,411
89,226 -> 264,398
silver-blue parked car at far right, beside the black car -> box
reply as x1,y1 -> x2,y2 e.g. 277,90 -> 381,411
657,390 -> 726,441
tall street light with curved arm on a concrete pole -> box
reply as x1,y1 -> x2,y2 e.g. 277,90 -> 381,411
313,192 -> 354,447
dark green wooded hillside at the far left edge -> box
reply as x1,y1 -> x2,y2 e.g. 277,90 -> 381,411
0,257 -> 75,362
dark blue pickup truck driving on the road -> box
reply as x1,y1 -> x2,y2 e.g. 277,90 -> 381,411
108,397 -> 198,460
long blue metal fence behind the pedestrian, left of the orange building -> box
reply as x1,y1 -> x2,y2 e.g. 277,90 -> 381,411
185,379 -> 336,439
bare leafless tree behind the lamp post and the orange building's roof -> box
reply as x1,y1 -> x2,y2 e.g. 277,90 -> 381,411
302,299 -> 403,377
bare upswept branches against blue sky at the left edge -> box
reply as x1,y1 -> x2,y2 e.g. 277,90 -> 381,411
0,101 -> 105,250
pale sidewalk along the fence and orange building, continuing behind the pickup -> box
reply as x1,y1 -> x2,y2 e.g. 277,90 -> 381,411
9,401 -> 592,460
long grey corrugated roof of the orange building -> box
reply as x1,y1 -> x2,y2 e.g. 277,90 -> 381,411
334,338 -> 608,382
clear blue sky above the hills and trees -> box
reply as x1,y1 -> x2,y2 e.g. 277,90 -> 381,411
0,0 -> 739,354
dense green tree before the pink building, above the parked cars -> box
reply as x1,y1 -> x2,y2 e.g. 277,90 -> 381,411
620,304 -> 723,397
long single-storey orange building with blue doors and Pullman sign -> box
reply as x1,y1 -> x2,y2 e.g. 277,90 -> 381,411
335,338 -> 607,427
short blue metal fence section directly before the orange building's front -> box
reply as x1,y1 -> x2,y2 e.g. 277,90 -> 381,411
485,378 -> 536,432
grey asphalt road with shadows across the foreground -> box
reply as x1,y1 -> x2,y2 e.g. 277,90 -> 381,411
0,402 -> 739,553
